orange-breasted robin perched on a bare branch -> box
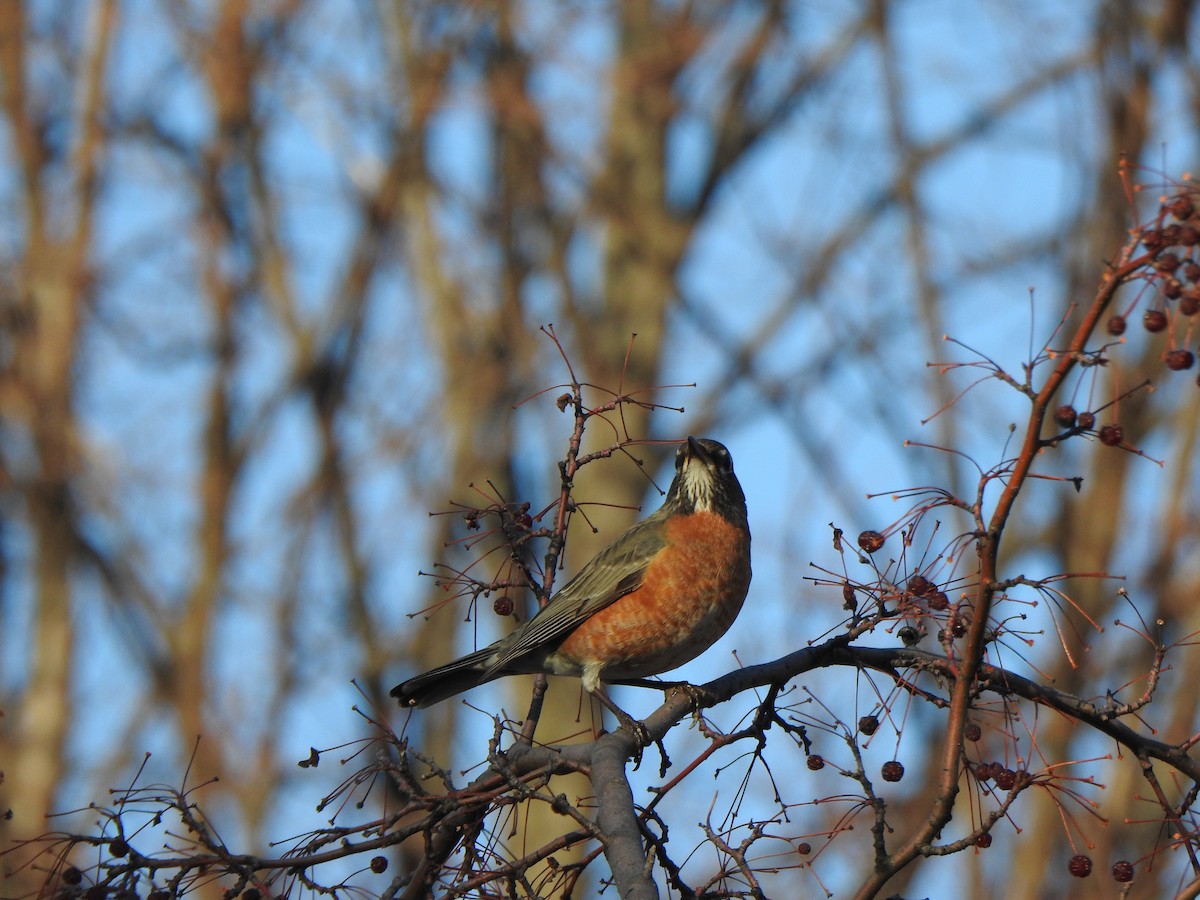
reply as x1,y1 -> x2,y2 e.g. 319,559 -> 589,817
391,437 -> 751,720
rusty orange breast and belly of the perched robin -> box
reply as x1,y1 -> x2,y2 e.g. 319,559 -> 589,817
556,512 -> 750,678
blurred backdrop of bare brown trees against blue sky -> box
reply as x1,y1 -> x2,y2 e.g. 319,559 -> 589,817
0,0 -> 1200,896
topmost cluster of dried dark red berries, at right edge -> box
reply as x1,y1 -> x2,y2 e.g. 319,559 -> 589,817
1108,187 -> 1200,385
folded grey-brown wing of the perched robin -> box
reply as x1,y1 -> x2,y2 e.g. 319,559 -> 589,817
487,510 -> 666,674
